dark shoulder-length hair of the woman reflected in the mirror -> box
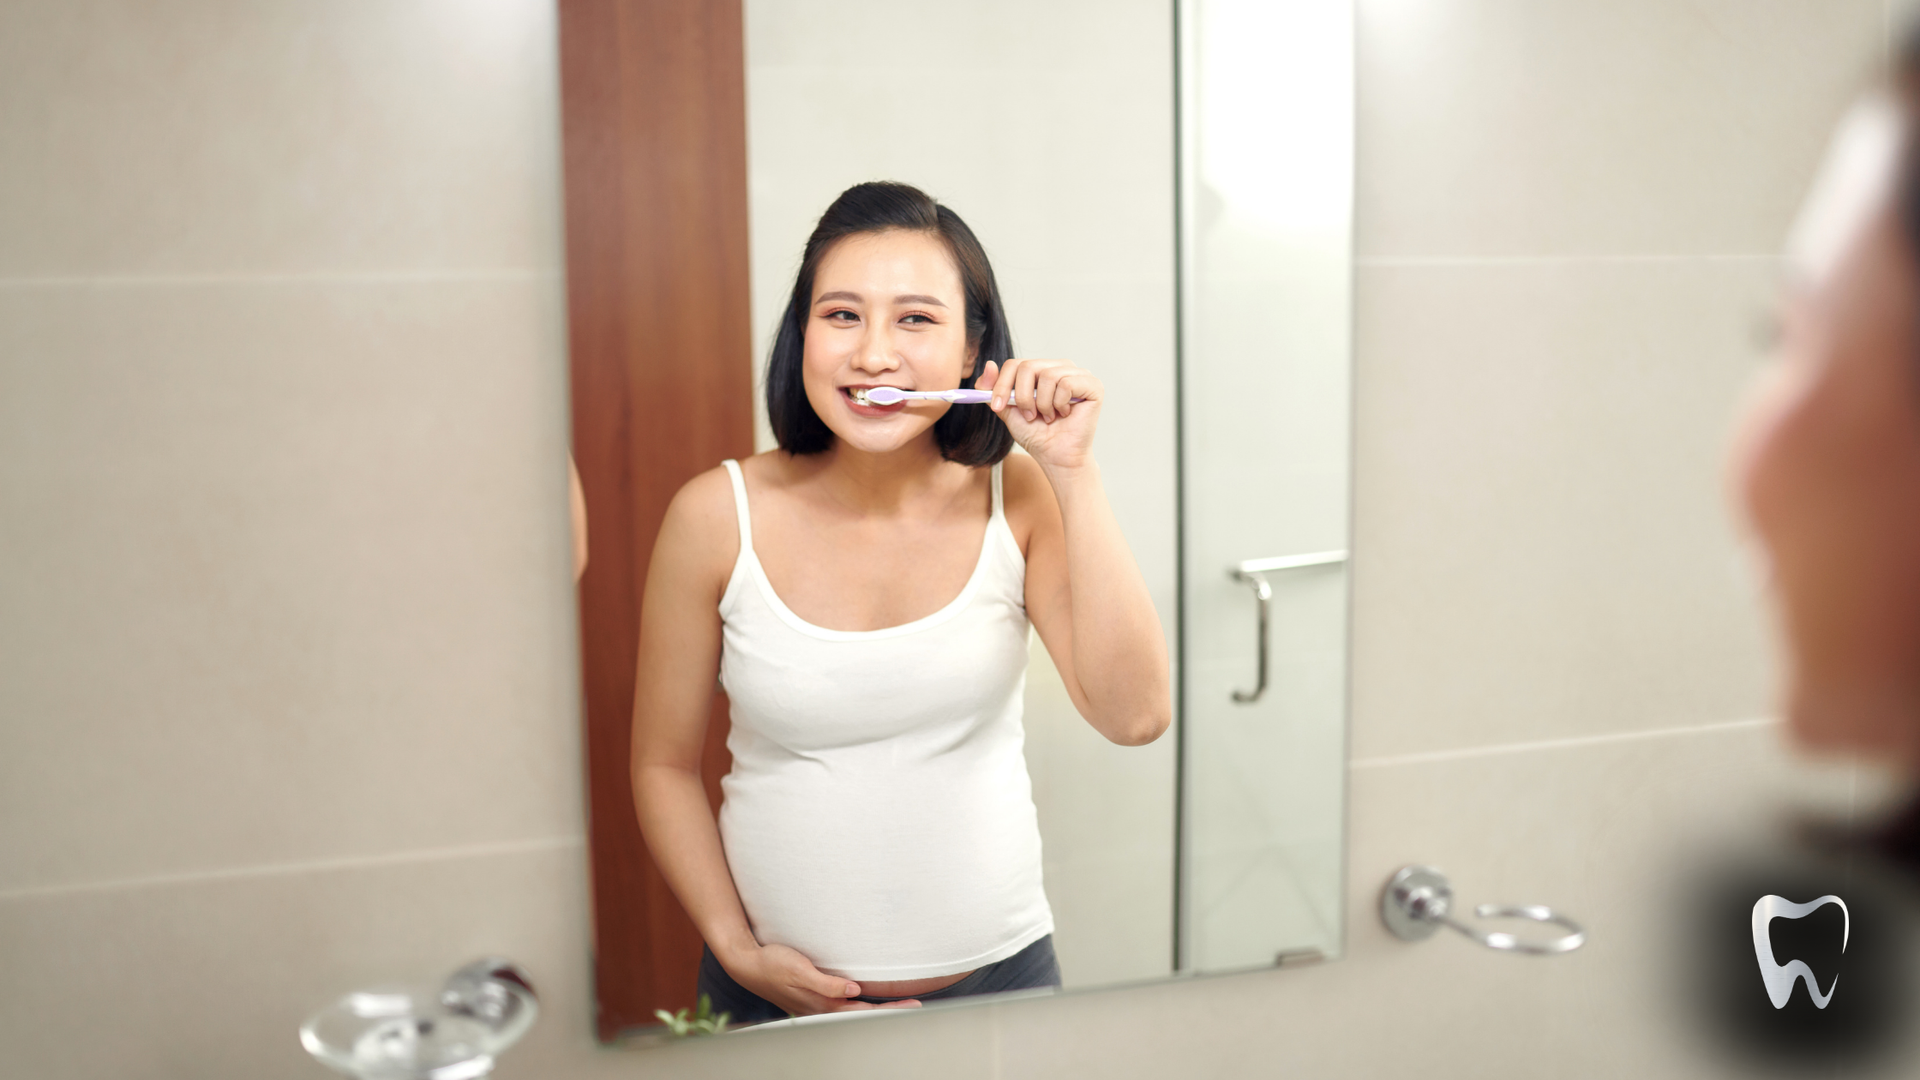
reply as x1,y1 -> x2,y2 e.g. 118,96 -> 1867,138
766,183 -> 1014,465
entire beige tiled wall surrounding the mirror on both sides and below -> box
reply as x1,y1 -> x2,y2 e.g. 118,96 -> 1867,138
0,0 -> 1889,1080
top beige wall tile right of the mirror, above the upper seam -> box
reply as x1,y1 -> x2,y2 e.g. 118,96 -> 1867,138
1357,0 -> 1884,258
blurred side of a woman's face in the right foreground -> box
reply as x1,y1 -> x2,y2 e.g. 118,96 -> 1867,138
1736,96 -> 1920,769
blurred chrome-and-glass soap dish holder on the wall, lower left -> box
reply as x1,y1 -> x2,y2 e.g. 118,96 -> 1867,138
300,957 -> 540,1080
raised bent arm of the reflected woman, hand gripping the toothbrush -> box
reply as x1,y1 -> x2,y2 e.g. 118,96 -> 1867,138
979,359 -> 1173,746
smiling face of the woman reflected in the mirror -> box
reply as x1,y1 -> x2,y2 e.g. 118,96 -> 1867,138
801,229 -> 972,454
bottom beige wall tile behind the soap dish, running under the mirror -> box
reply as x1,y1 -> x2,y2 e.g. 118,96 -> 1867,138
0,846 -> 993,1080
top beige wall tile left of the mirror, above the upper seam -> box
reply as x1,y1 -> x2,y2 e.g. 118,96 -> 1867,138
0,0 -> 561,277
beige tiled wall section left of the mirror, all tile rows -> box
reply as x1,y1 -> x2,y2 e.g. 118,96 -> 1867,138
0,0 -> 588,1078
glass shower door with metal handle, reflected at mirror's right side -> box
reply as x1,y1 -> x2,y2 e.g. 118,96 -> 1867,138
1179,0 -> 1354,970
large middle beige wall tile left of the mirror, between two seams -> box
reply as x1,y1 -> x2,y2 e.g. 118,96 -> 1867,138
0,277 -> 582,892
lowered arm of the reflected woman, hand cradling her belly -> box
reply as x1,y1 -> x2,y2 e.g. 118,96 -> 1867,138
632,469 -> 913,1013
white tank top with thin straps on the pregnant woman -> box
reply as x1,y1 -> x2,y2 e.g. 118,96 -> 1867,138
720,461 -> 1054,980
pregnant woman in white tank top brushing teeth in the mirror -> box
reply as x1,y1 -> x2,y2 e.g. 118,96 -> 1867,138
634,183 -> 1171,1022
